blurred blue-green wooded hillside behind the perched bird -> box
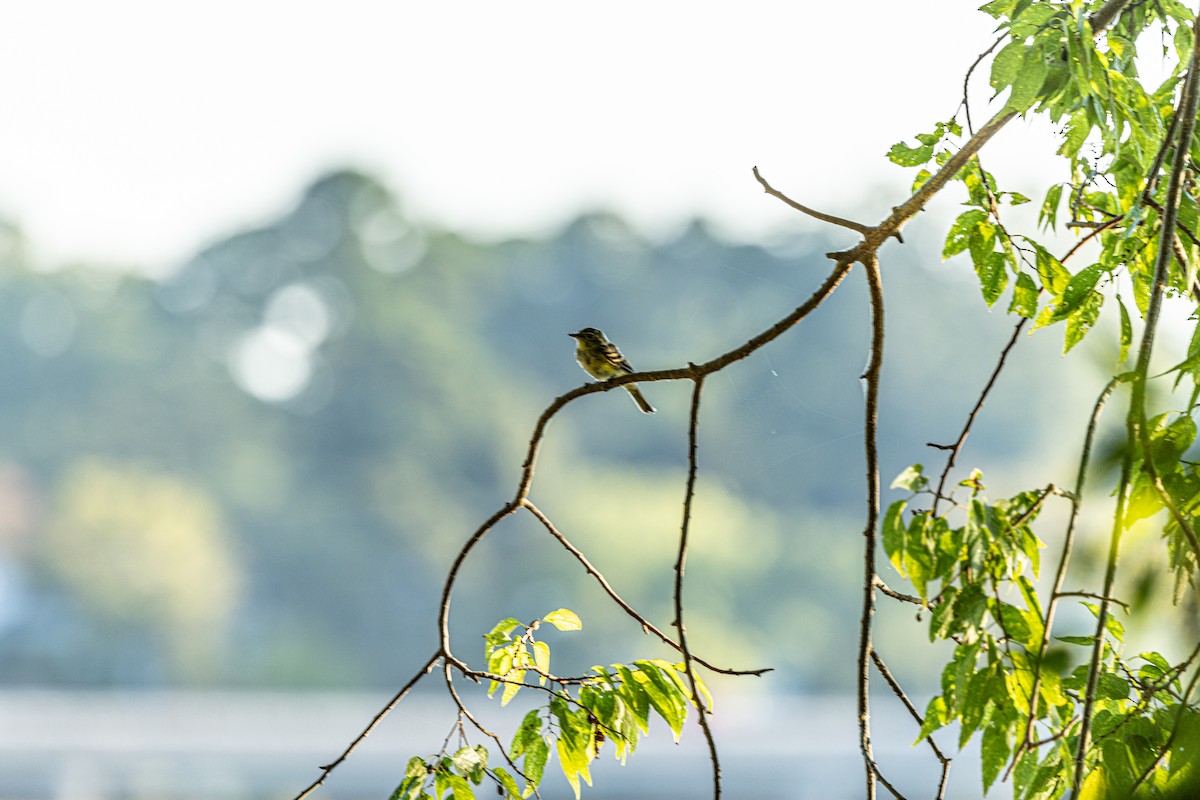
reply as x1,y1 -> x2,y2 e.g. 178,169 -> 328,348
0,173 -> 1111,690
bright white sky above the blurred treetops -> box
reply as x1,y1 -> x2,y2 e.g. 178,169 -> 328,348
0,0 -> 1046,267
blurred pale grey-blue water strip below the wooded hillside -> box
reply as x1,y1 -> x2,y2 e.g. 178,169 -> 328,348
0,691 -> 984,800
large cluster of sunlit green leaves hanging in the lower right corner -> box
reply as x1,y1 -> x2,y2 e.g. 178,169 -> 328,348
882,460 -> 1200,800
